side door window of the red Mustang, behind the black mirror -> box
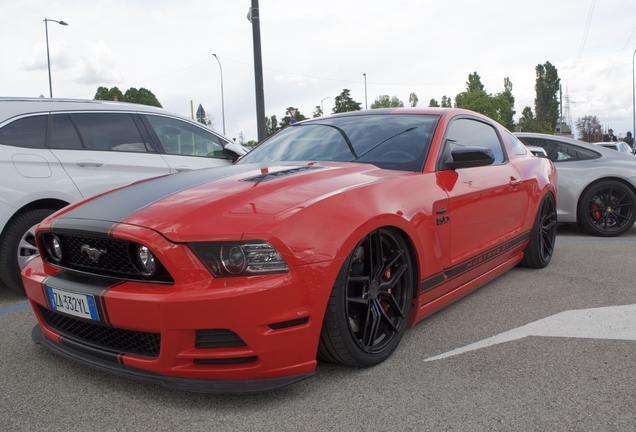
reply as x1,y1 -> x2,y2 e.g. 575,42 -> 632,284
446,119 -> 504,165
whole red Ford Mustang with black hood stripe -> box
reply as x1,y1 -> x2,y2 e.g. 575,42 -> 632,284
22,109 -> 557,392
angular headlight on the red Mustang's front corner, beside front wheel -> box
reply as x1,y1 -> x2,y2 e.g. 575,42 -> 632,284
190,240 -> 289,277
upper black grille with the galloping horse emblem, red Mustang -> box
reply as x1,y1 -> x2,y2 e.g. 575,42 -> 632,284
47,233 -> 174,283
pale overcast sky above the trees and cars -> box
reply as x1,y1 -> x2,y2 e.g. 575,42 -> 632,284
0,0 -> 636,140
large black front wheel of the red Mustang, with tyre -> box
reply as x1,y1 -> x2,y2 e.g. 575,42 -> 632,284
318,228 -> 414,366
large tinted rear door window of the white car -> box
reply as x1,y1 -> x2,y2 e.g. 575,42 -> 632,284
73,113 -> 146,152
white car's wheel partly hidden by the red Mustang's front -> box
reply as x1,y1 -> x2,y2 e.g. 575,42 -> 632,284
0,209 -> 55,293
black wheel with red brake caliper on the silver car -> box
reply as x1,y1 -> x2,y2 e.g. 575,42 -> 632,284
578,180 -> 636,237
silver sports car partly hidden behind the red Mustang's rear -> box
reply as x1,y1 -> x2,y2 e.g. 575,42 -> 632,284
515,132 -> 636,237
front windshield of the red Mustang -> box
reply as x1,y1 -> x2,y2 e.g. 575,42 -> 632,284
238,114 -> 439,172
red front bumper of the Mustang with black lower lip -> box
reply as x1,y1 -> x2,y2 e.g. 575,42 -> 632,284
23,258 -> 339,393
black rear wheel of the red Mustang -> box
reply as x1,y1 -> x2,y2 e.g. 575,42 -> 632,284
521,193 -> 557,268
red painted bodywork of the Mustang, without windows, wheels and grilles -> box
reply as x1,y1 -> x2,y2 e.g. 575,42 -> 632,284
23,110 -> 556,392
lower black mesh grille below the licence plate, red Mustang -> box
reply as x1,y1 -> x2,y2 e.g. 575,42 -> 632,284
39,306 -> 161,358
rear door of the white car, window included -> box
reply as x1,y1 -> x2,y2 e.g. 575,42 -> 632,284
47,112 -> 170,197
